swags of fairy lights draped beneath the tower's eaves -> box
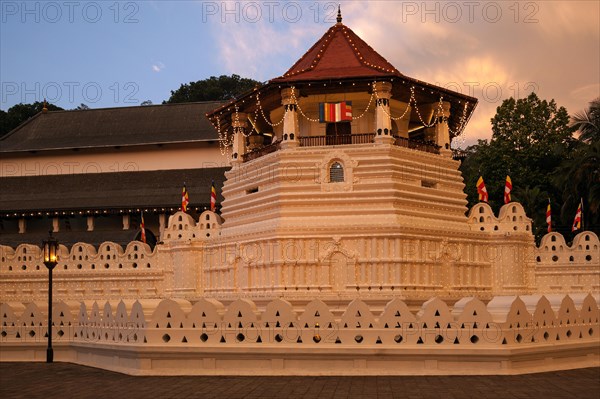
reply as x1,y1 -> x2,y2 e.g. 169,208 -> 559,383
211,82 -> 468,156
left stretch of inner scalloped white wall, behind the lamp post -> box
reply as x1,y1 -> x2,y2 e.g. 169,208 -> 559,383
0,241 -> 165,302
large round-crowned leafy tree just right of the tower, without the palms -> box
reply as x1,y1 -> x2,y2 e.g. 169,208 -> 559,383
461,93 -> 577,238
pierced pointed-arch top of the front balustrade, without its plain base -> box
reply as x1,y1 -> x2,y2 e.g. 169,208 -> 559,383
0,294 -> 600,348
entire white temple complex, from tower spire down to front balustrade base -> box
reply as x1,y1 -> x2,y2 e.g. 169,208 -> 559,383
0,8 -> 600,375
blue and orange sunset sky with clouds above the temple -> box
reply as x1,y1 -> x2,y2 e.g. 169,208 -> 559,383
0,0 -> 600,146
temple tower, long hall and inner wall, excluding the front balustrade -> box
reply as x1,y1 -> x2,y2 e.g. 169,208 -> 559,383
0,10 -> 600,306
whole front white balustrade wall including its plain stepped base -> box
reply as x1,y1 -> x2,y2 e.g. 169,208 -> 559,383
0,294 -> 600,374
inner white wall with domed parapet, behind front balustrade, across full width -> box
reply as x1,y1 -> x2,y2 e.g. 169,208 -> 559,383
0,208 -> 600,302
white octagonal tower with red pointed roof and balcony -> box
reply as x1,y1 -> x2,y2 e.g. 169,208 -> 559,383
204,12 -> 533,298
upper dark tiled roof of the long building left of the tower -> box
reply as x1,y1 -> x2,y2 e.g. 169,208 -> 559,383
0,101 -> 222,152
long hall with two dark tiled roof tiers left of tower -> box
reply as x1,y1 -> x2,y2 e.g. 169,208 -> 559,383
0,102 -> 228,247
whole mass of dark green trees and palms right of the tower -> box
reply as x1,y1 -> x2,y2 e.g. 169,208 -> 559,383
461,93 -> 600,239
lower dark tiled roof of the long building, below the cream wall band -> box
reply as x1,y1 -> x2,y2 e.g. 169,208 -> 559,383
0,168 -> 228,214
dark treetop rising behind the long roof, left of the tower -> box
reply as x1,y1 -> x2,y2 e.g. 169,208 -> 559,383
164,75 -> 261,104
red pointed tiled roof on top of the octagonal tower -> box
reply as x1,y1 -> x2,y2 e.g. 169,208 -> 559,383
273,23 -> 399,82
